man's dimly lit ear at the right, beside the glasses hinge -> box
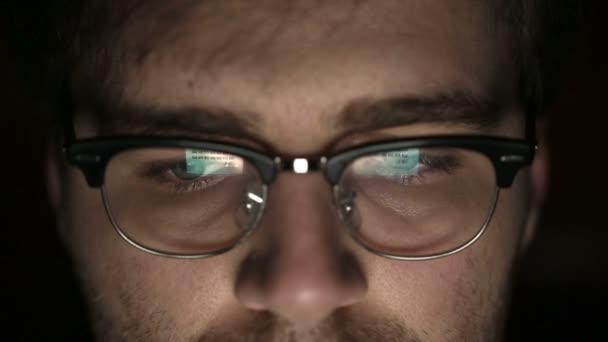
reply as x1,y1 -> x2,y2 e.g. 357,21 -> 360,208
522,120 -> 549,249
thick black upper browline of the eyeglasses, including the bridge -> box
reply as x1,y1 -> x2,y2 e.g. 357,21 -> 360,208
66,135 -> 536,188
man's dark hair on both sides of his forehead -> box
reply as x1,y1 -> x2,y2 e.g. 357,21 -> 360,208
9,0 -> 582,127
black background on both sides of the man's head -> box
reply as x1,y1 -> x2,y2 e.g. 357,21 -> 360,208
5,1 -> 608,341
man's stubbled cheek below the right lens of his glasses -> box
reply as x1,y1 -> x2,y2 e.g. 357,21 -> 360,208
360,177 -> 527,340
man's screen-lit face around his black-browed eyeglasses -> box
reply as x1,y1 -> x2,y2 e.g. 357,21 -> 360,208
51,0 -> 530,341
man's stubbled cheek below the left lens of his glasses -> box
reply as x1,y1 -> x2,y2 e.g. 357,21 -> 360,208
64,170 -> 235,333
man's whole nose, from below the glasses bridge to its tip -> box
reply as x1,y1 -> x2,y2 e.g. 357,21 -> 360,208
235,175 -> 367,327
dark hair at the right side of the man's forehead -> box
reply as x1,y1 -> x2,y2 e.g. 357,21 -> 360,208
498,0 -> 582,115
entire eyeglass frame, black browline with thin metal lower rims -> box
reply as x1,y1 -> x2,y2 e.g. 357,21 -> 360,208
63,88 -> 538,260
